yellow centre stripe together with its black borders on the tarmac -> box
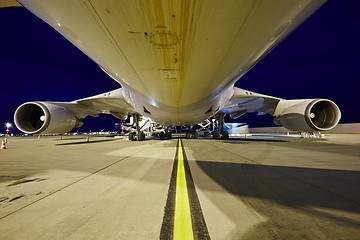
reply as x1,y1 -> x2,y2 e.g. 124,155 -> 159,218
160,139 -> 210,239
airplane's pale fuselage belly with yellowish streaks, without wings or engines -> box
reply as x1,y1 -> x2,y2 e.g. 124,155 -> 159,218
20,0 -> 324,125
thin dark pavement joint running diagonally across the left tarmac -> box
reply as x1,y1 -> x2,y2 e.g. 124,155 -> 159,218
0,142 -> 152,220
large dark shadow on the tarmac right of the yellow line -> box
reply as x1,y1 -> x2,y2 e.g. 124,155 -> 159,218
196,160 -> 360,227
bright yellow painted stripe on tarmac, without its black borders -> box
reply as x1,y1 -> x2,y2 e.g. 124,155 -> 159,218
174,139 -> 194,240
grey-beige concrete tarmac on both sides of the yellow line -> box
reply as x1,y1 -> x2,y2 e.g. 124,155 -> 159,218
0,134 -> 360,240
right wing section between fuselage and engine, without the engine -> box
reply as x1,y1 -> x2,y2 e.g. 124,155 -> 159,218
221,87 -> 282,119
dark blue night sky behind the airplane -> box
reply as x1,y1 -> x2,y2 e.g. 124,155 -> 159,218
0,0 -> 360,133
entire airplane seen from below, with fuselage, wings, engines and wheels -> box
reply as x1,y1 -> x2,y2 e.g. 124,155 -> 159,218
0,0 -> 341,140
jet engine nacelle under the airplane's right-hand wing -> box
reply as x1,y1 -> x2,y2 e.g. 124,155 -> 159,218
274,99 -> 341,132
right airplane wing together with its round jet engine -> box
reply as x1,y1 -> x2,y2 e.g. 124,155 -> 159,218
221,87 -> 341,131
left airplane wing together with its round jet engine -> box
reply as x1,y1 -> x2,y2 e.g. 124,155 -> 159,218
14,88 -> 136,134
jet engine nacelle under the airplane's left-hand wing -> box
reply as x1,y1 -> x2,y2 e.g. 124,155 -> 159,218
14,102 -> 82,134
